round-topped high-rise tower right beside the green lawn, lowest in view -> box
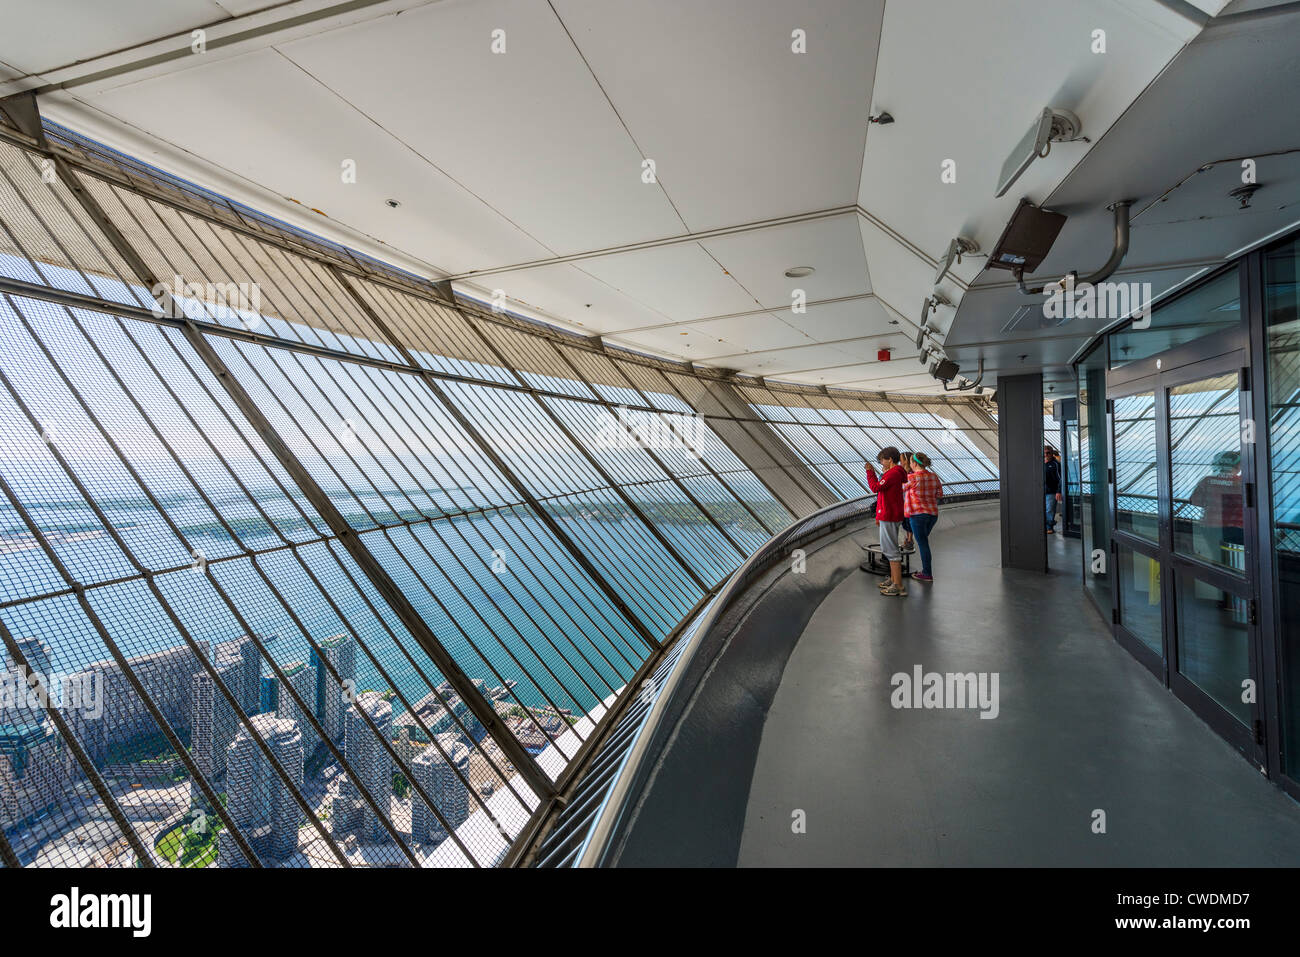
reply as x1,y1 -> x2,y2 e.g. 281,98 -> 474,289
217,714 -> 303,867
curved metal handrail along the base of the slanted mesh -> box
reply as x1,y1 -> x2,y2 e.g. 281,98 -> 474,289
577,494 -> 876,867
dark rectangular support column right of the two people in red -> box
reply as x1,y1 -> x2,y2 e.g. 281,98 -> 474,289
997,372 -> 1048,572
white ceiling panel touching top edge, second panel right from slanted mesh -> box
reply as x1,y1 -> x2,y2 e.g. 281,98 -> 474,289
282,0 -> 685,254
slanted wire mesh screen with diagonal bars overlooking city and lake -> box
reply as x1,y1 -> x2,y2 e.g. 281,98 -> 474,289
0,117 -> 996,867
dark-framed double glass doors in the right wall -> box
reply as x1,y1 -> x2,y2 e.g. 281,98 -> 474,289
1109,354 -> 1264,766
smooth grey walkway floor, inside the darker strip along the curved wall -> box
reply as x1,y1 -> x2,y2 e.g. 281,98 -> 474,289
738,520 -> 1300,866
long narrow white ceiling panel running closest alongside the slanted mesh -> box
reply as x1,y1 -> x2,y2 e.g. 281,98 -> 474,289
74,49 -> 547,272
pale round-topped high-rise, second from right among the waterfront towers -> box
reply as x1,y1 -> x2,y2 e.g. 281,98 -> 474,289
332,692 -> 393,841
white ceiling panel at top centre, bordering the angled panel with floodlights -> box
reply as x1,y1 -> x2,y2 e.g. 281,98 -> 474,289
543,0 -> 884,230
